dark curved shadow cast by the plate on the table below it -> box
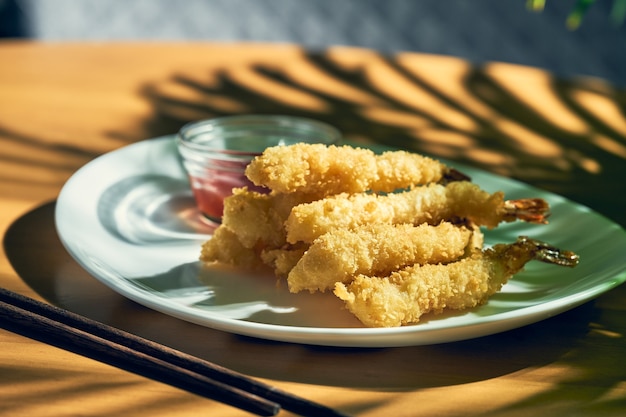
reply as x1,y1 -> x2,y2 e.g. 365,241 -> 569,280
0,203 -> 626,411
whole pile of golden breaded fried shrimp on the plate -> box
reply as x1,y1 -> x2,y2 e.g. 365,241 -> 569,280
200,144 -> 578,327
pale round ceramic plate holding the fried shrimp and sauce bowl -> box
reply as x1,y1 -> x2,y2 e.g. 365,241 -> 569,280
56,137 -> 626,347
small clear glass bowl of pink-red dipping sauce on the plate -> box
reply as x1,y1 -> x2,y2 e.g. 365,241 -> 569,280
176,115 -> 341,223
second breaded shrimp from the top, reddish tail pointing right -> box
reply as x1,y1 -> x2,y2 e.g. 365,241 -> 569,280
285,181 -> 548,243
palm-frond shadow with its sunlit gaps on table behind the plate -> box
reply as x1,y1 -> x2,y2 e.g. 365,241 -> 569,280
118,48 -> 626,225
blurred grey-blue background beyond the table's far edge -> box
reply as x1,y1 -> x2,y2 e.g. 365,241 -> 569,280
0,0 -> 626,87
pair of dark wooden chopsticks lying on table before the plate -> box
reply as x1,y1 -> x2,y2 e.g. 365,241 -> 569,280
0,288 -> 346,417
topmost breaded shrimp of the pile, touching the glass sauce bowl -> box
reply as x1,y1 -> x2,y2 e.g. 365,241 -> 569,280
241,144 -> 456,198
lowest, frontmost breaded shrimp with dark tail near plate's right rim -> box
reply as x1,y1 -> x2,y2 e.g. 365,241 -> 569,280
334,237 -> 578,327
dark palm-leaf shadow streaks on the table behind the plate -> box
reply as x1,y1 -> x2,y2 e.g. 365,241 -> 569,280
134,52 -> 626,224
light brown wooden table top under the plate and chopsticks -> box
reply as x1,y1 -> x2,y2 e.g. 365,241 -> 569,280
0,42 -> 626,417
